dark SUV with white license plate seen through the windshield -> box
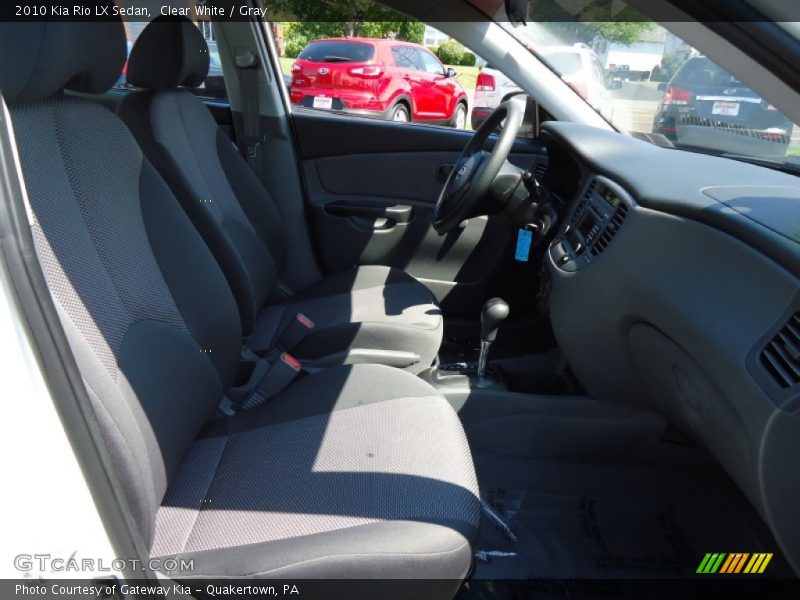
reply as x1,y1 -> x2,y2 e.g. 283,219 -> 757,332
653,56 -> 792,159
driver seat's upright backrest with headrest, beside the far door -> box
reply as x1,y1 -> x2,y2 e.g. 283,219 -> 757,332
118,18 -> 287,333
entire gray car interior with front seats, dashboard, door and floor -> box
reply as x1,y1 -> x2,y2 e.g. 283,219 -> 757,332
0,2 -> 800,598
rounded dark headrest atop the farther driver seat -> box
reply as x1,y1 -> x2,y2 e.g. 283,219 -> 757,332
128,16 -> 210,90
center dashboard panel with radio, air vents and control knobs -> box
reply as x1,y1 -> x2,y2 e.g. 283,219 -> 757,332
549,175 -> 635,271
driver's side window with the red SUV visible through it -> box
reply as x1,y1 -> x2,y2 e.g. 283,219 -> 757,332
270,16 -> 518,134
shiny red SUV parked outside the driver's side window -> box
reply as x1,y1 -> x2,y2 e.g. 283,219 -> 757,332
290,38 -> 469,129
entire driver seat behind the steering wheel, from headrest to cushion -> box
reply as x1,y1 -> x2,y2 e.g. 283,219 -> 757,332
118,18 -> 443,373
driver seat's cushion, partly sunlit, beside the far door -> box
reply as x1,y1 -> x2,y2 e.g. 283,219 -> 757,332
248,266 -> 443,372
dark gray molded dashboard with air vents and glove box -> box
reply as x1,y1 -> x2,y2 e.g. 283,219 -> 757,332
542,122 -> 800,572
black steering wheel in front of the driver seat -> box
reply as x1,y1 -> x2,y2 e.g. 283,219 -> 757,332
433,98 -> 525,234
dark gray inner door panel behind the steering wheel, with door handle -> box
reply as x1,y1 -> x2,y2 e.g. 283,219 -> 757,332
295,111 -> 543,316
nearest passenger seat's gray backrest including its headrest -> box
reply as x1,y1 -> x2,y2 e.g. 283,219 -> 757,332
0,14 -> 241,543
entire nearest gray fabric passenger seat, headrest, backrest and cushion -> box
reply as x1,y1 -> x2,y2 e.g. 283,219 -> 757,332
0,11 -> 479,581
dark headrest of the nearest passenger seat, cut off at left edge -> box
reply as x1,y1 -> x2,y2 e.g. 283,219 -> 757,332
0,10 -> 126,104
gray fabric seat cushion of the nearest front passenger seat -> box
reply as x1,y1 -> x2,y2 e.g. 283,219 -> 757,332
152,365 -> 480,580
